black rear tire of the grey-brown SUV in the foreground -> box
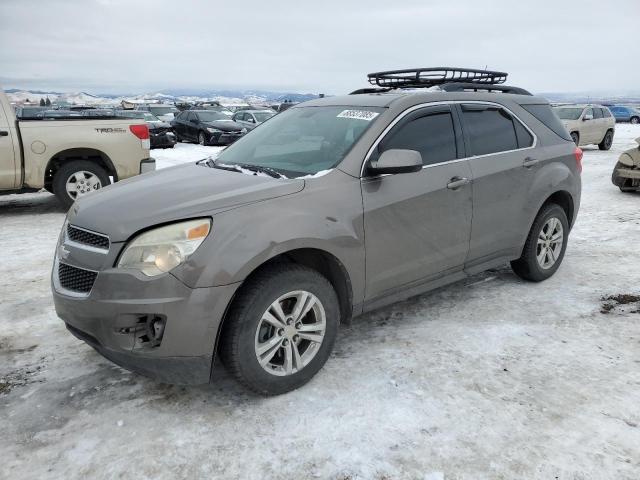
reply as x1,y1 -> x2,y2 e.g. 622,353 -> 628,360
511,203 -> 569,282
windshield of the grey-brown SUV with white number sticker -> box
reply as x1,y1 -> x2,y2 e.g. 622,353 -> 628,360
218,107 -> 383,178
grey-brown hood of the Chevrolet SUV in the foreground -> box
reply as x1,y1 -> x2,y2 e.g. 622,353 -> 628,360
68,163 -> 304,242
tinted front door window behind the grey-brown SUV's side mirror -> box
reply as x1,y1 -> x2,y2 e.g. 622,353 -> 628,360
378,111 -> 458,165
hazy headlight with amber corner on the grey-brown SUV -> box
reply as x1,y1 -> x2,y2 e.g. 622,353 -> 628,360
118,218 -> 211,277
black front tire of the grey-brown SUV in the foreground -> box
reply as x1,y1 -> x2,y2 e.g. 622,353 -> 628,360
219,264 -> 340,395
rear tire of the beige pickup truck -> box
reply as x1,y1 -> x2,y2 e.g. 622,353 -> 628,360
52,160 -> 110,209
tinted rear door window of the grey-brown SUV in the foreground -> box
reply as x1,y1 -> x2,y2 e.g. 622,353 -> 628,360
462,104 -> 533,156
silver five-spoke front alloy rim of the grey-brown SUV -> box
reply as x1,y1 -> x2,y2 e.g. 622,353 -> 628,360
255,290 -> 326,376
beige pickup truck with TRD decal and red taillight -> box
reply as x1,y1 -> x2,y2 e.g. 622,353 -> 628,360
0,89 -> 155,207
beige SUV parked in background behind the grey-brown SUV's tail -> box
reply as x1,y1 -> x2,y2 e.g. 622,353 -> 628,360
554,105 -> 616,150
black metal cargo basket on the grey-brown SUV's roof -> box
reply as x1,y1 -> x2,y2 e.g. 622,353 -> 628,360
352,67 -> 531,95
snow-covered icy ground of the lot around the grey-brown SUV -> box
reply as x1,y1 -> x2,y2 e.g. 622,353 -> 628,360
0,125 -> 640,480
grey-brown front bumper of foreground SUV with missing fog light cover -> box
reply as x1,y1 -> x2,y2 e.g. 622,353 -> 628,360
52,258 -> 238,384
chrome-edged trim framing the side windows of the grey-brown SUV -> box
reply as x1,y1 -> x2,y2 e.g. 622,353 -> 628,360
360,100 -> 538,178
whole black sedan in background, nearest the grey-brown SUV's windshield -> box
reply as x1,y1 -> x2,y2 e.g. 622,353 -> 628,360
171,110 -> 247,145
